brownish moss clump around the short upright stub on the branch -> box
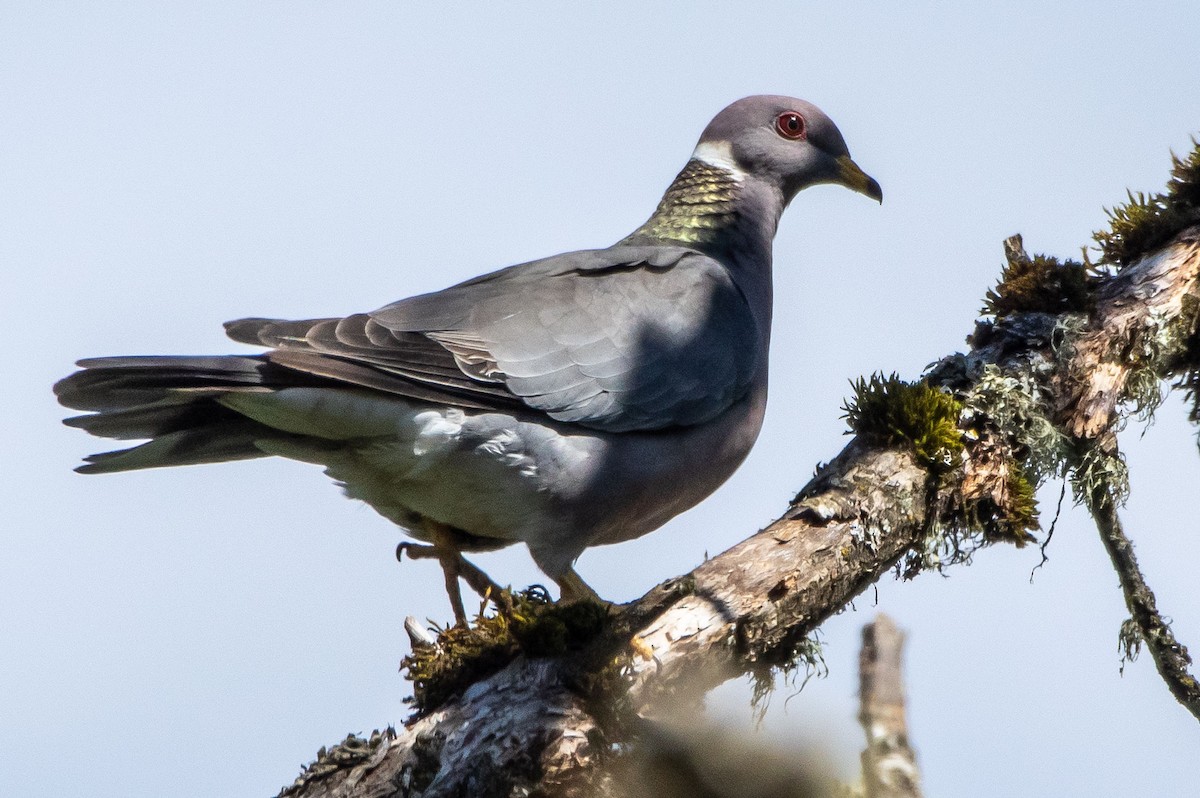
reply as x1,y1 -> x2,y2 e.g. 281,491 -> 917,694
982,252 -> 1094,318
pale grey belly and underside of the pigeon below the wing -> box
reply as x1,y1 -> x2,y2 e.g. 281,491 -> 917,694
244,390 -> 766,577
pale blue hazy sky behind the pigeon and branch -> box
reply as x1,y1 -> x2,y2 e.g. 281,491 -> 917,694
0,1 -> 1200,797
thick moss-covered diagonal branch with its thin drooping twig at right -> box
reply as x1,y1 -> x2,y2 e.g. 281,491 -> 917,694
276,143 -> 1200,798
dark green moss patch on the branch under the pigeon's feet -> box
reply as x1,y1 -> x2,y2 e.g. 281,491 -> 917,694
401,587 -> 608,713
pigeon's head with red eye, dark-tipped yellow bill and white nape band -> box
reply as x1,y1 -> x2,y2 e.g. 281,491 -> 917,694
692,95 -> 883,204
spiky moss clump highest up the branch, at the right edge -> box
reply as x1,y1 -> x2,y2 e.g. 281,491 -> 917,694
1093,139 -> 1200,266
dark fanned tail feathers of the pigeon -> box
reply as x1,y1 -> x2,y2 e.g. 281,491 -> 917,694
54,355 -> 328,474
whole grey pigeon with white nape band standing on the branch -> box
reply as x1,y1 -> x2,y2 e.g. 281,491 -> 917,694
54,95 -> 883,623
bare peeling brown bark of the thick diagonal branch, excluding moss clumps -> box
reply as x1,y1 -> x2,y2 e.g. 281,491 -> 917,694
284,228 -> 1200,798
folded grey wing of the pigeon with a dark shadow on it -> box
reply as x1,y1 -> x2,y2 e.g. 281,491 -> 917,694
227,246 -> 766,432
